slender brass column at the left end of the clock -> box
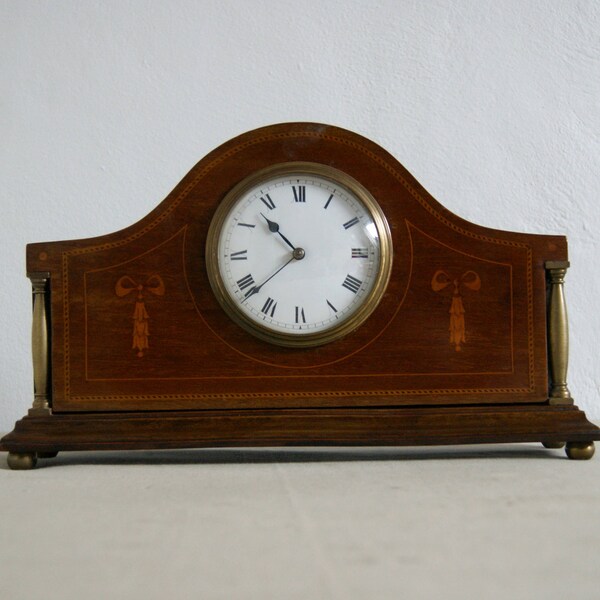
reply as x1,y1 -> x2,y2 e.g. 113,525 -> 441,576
27,273 -> 50,415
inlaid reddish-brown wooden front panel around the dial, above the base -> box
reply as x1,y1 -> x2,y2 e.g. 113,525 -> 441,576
27,124 -> 567,411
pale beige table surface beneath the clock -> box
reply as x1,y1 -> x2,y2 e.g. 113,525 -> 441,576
0,444 -> 600,600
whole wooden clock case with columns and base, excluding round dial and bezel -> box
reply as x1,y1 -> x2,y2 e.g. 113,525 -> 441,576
0,123 -> 600,468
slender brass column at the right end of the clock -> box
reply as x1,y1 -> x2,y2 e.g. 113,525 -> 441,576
545,261 -> 573,404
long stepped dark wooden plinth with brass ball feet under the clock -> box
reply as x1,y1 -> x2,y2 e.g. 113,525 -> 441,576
0,404 -> 600,469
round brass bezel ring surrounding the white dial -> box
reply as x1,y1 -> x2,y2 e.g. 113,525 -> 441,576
206,161 -> 393,348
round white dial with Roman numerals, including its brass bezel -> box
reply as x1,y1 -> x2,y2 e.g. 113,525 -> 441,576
207,163 -> 392,346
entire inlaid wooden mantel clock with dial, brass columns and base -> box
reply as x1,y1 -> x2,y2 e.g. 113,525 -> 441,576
0,123 -> 600,469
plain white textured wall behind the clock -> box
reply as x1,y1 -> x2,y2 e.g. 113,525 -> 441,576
0,0 -> 600,431
